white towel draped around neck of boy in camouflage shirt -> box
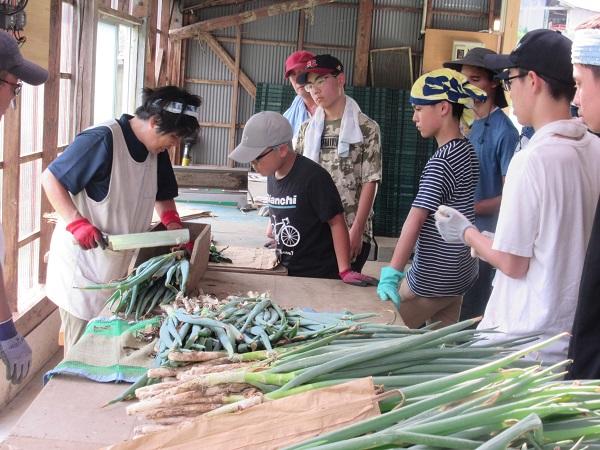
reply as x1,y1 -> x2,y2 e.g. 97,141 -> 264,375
303,95 -> 363,163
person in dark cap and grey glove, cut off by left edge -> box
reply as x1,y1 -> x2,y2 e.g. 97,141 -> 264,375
0,31 -> 48,384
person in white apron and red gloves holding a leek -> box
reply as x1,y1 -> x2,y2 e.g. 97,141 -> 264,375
42,86 -> 200,355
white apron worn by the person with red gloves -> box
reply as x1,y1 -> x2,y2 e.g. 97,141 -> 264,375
46,120 -> 158,320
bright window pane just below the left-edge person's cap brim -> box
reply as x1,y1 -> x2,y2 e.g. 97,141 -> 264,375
21,84 -> 44,156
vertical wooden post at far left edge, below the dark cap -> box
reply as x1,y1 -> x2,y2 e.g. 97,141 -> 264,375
2,96 -> 21,311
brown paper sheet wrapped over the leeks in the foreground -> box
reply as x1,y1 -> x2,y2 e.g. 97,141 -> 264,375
106,377 -> 379,450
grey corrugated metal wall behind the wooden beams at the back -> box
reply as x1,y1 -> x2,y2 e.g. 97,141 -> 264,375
183,0 -> 492,165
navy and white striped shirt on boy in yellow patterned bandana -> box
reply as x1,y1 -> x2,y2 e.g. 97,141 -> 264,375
406,139 -> 479,297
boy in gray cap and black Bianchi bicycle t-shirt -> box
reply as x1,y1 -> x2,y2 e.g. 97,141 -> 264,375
229,111 -> 377,286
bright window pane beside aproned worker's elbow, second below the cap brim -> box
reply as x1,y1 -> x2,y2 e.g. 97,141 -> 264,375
19,159 -> 42,239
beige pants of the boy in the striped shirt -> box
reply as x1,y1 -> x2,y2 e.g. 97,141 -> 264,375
400,278 -> 462,328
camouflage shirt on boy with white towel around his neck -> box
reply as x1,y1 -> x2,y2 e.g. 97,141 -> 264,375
296,113 -> 381,243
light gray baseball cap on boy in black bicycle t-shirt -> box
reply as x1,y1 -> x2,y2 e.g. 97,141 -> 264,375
229,111 -> 294,163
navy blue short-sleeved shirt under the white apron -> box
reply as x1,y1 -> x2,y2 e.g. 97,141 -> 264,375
48,114 -> 178,202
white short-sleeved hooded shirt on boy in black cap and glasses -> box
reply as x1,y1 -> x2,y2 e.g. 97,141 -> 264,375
479,119 -> 600,363
